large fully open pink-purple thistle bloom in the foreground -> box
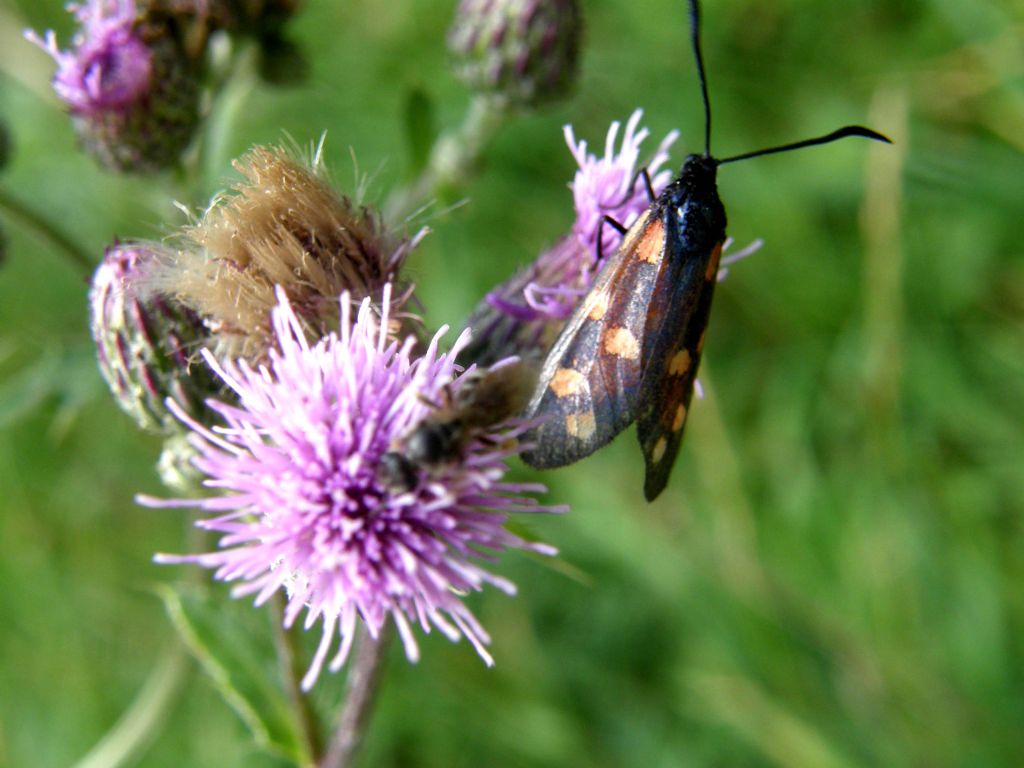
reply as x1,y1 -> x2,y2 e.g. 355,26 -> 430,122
139,290 -> 563,689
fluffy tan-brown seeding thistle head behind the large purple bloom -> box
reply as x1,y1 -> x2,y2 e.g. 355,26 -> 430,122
159,146 -> 422,361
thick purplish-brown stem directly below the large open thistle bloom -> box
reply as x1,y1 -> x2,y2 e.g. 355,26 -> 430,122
318,624 -> 391,768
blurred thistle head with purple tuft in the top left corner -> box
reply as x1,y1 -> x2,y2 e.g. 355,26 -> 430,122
26,0 -> 199,171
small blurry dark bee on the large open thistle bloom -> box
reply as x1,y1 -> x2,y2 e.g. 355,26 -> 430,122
381,357 -> 537,490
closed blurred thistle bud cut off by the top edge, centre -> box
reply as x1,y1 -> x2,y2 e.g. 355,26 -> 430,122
449,0 -> 583,106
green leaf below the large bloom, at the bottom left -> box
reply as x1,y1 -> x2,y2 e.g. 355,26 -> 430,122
157,586 -> 311,765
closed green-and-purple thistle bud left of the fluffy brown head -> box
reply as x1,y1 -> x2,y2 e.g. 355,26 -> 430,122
89,244 -> 220,434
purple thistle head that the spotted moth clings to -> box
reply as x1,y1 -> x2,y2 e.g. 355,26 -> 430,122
468,110 -> 679,362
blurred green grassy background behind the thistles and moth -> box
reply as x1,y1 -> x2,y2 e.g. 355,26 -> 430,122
0,0 -> 1024,768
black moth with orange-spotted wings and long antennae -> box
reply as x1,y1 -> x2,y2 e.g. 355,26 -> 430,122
522,0 -> 889,501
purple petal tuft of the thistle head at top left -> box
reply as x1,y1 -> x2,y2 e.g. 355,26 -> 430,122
26,0 -> 153,114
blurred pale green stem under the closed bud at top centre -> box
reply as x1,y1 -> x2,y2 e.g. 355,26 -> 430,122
384,95 -> 508,223
